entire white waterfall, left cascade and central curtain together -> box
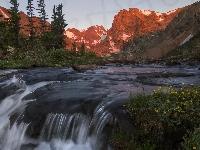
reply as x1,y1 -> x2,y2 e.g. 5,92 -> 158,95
0,76 -> 116,150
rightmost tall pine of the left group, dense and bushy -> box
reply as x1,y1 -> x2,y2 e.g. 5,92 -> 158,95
50,4 -> 68,49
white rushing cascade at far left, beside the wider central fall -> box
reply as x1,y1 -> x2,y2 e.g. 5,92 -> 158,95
0,76 -> 56,150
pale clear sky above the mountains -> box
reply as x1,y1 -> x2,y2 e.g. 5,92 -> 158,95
0,0 -> 198,30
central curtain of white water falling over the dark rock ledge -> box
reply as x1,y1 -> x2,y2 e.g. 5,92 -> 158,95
35,109 -> 112,150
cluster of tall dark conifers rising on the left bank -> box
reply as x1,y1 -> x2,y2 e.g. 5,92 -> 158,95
0,0 -> 67,51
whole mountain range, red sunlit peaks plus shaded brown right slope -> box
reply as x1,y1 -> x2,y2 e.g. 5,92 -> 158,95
0,2 -> 200,60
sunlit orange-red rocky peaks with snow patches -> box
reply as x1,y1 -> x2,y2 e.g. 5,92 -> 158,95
0,7 -> 182,55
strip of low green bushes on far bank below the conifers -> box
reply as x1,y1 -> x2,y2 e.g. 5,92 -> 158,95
0,49 -> 100,69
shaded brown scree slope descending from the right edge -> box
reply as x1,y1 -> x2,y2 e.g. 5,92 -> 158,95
116,2 -> 200,61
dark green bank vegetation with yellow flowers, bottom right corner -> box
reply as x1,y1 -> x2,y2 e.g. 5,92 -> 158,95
111,83 -> 200,150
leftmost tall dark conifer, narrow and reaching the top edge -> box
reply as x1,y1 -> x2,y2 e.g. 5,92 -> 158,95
8,0 -> 21,48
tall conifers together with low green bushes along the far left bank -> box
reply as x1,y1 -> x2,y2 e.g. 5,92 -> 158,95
0,0 -> 98,68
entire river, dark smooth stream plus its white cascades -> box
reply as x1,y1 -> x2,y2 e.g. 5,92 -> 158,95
0,65 -> 199,150
